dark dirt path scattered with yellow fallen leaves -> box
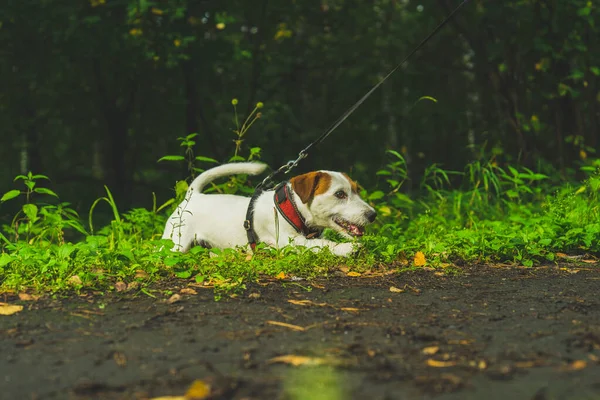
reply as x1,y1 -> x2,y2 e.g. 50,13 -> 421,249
0,266 -> 600,400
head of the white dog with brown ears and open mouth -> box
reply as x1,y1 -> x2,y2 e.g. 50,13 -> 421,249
290,171 -> 377,238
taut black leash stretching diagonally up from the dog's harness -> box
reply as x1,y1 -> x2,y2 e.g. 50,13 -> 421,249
256,0 -> 469,191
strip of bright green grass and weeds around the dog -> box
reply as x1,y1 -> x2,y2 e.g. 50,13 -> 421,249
0,103 -> 600,297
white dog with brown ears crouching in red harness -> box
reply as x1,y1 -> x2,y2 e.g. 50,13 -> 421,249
162,162 -> 377,257
